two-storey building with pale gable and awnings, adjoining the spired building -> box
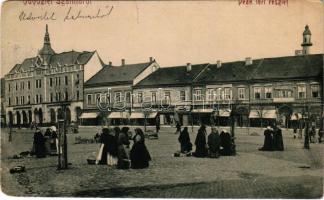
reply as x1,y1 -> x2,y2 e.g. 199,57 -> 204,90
80,58 -> 160,125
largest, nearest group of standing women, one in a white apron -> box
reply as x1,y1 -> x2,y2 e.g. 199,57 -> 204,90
96,127 -> 151,169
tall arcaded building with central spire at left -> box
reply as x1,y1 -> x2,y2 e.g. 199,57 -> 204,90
5,25 -> 103,126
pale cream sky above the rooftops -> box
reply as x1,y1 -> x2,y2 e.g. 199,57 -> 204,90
1,0 -> 324,77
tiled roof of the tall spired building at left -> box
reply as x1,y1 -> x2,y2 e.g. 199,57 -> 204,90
9,51 -> 95,74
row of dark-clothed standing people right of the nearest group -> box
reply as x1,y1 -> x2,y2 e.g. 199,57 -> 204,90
178,125 -> 235,158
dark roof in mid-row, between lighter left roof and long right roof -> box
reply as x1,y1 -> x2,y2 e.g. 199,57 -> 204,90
136,63 -> 208,87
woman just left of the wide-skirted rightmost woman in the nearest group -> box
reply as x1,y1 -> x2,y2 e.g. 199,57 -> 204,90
117,127 -> 129,169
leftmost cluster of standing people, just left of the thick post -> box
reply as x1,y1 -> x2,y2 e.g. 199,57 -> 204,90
30,126 -> 58,158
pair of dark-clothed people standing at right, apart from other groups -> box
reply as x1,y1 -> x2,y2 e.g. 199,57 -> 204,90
259,126 -> 284,151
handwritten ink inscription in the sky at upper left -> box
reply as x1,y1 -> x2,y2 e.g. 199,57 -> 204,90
18,6 -> 114,22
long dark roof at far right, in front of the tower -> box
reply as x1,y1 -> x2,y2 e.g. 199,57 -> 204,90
196,54 -> 323,83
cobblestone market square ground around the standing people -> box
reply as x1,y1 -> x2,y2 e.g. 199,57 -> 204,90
1,127 -> 323,198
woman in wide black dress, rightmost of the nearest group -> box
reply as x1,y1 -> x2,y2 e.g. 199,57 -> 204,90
130,128 -> 151,169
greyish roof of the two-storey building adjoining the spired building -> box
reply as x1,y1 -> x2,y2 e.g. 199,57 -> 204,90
84,61 -> 155,87
